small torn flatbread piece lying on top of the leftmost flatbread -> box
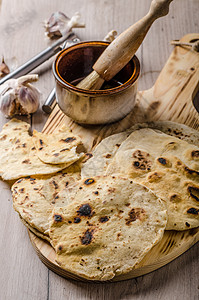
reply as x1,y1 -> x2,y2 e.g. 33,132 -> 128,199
33,125 -> 84,166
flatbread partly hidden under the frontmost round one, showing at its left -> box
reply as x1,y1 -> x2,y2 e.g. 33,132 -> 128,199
11,163 -> 80,236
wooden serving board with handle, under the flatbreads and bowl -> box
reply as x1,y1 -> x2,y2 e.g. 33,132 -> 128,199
29,34 -> 199,281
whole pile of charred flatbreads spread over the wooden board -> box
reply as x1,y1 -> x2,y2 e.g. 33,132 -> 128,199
0,120 -> 199,280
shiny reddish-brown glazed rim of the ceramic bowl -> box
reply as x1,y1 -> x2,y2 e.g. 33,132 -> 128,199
52,41 -> 140,96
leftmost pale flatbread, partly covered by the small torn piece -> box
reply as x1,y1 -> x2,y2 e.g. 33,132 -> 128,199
0,119 -> 70,180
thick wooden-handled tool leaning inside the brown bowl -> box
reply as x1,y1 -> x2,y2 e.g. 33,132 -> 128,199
77,0 -> 173,90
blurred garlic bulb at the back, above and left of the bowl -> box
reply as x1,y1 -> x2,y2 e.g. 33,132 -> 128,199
45,12 -> 85,38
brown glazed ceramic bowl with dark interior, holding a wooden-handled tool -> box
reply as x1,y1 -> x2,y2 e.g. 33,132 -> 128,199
53,41 -> 140,124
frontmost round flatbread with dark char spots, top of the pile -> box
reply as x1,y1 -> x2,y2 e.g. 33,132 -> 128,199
50,176 -> 167,280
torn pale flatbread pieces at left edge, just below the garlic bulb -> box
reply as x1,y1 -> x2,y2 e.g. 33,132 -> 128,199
0,119 -> 84,180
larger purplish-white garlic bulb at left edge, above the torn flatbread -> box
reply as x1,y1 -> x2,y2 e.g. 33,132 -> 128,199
0,74 -> 41,117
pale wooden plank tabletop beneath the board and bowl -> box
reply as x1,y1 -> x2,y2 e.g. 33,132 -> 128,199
0,0 -> 199,300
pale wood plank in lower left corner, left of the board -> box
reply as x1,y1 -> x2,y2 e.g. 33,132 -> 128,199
0,182 -> 48,300
